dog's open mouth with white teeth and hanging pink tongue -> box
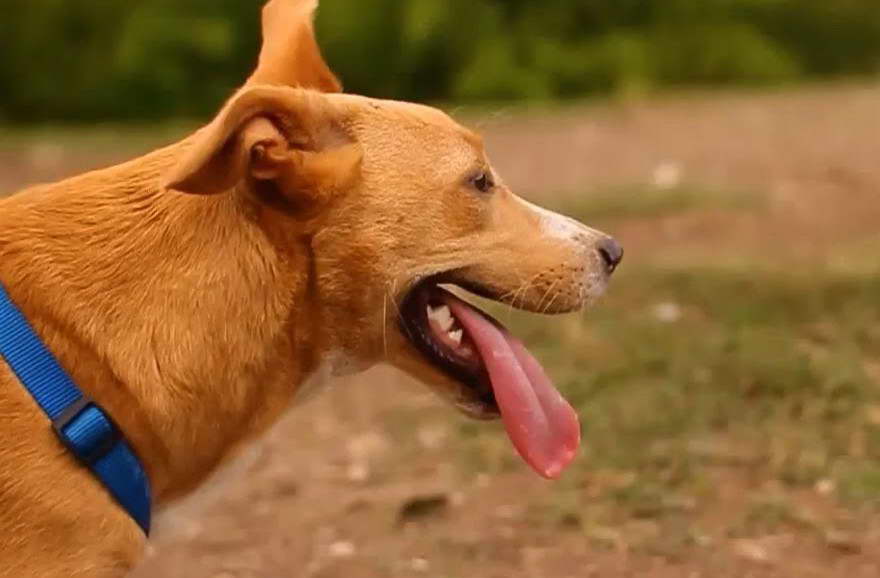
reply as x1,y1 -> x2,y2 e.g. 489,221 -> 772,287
401,277 -> 580,479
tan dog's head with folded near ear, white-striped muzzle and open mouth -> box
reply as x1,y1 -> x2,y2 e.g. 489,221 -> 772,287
167,1 -> 622,477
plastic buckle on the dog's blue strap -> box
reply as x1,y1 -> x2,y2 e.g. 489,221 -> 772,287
52,397 -> 122,467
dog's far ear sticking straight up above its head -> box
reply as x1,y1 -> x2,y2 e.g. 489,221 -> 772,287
247,0 -> 342,92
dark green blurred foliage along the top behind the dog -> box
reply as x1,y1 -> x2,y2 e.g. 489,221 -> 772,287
0,0 -> 880,122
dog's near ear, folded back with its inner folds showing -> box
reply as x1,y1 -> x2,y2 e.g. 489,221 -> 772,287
163,86 -> 361,199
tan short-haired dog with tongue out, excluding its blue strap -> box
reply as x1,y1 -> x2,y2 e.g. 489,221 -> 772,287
0,0 -> 621,578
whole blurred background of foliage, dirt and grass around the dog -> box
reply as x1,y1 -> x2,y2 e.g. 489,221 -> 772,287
0,0 -> 880,578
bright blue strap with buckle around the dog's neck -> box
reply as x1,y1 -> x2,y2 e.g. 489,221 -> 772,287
0,284 -> 151,535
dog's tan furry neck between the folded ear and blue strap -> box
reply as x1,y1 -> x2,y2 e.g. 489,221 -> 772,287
0,141 -> 323,503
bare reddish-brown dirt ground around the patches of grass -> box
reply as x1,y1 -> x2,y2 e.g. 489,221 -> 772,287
0,86 -> 880,578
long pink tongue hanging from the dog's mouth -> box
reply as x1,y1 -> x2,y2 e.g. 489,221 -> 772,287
448,298 -> 581,479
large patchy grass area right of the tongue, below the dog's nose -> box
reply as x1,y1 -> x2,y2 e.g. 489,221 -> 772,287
463,267 -> 880,531
